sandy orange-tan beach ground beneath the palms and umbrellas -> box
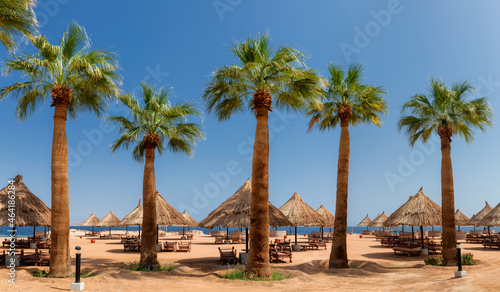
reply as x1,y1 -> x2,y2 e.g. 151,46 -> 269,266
0,231 -> 500,291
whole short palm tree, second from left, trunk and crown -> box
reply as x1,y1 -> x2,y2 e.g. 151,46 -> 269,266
108,84 -> 204,268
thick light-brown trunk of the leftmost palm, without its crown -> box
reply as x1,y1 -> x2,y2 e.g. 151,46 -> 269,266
49,104 -> 71,278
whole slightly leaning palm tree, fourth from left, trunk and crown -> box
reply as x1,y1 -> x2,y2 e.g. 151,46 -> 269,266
308,64 -> 387,268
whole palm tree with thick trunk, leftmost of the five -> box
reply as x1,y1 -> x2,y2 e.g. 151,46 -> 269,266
0,22 -> 120,277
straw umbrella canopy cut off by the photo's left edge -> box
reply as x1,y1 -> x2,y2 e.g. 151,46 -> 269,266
0,175 -> 51,237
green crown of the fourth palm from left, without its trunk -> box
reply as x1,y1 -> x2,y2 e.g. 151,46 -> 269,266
308,64 -> 387,130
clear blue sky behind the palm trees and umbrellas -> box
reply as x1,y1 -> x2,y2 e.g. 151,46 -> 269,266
0,0 -> 500,225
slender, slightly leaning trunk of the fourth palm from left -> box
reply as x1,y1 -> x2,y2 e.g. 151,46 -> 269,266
329,118 -> 350,269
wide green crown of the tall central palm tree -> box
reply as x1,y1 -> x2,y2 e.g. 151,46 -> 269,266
203,34 -> 321,120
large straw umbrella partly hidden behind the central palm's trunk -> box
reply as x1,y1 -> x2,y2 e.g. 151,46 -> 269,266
198,179 -> 292,250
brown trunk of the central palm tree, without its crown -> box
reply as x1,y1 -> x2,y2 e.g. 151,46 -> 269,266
246,107 -> 271,278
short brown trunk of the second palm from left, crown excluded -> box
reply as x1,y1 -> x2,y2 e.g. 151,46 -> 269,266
139,148 -> 159,268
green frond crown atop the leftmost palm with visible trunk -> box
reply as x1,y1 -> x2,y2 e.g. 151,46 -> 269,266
0,22 -> 120,120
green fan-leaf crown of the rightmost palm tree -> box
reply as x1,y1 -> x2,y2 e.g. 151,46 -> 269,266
398,78 -> 493,146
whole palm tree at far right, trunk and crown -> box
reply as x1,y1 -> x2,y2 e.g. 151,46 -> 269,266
398,78 -> 492,265
